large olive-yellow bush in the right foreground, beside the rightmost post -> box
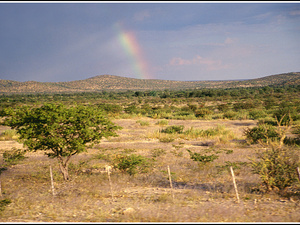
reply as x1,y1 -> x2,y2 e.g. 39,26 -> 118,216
251,147 -> 299,192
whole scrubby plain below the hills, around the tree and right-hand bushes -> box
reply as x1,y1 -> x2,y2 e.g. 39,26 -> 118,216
0,87 -> 300,222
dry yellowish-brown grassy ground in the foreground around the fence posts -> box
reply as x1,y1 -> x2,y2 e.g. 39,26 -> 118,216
0,118 -> 300,222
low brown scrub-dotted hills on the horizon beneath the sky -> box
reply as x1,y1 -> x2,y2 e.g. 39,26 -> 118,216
0,72 -> 300,94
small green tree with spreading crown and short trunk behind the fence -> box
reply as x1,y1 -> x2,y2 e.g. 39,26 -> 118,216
4,103 -> 120,180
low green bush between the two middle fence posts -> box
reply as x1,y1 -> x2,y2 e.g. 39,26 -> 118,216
113,154 -> 149,176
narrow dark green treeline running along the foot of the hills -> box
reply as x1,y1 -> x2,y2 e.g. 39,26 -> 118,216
0,85 -> 300,103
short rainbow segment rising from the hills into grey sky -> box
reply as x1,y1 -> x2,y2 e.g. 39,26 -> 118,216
115,23 -> 152,79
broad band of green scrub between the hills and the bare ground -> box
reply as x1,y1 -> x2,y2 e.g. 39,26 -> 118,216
0,85 -> 300,123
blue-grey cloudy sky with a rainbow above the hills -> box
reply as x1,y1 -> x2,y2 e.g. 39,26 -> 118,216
0,1 -> 300,82
